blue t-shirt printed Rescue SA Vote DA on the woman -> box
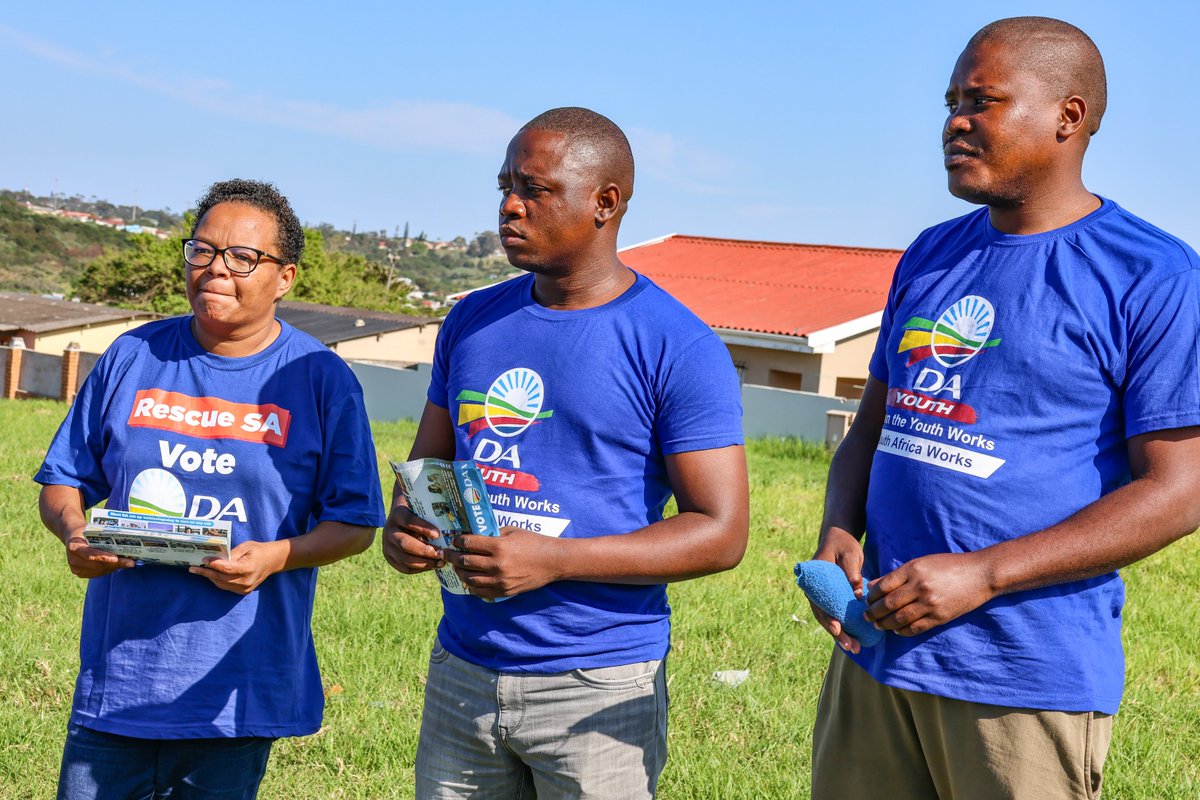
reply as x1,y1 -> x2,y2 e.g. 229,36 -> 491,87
35,317 -> 383,739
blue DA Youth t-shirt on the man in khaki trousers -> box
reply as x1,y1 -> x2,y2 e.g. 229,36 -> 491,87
856,200 -> 1200,714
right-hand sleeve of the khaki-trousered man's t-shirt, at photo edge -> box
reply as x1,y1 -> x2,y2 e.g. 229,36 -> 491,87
1123,266 -> 1200,438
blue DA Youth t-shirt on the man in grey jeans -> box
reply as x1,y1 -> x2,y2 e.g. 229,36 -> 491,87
428,275 -> 742,673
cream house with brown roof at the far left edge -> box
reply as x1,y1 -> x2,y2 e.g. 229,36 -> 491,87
0,291 -> 160,355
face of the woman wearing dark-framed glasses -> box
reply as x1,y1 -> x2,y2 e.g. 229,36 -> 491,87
184,201 -> 296,339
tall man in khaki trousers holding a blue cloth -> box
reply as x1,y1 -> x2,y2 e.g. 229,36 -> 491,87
812,17 -> 1200,800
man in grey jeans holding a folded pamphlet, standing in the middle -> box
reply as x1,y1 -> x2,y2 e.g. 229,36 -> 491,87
383,108 -> 749,799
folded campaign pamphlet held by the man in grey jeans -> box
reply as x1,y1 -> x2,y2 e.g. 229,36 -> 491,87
391,458 -> 504,600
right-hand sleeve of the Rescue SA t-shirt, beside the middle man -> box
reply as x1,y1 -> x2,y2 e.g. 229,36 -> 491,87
312,387 -> 384,528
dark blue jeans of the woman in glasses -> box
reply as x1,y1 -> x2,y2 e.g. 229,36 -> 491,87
58,724 -> 275,800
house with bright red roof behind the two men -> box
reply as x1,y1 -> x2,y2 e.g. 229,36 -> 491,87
620,234 -> 902,399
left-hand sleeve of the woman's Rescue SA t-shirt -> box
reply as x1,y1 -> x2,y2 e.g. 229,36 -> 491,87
34,359 -> 112,509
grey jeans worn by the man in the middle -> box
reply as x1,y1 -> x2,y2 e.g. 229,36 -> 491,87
416,642 -> 667,800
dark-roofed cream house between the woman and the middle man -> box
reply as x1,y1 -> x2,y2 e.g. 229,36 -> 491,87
275,300 -> 442,365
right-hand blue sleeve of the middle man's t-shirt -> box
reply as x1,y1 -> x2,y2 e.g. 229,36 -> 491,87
656,335 -> 744,455
